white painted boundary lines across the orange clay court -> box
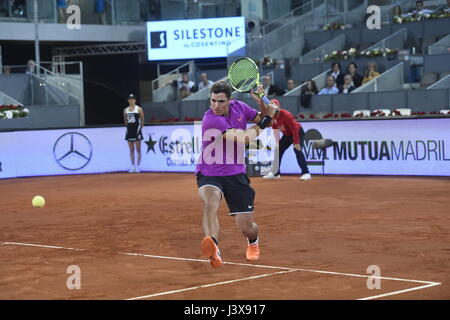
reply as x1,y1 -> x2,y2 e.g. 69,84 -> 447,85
0,242 -> 441,300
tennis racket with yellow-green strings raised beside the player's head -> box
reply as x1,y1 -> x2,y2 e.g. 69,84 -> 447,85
228,57 -> 270,104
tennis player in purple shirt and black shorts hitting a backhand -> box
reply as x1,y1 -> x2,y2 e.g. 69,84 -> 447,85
195,81 -> 277,268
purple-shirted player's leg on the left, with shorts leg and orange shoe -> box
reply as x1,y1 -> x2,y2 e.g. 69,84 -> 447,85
197,179 -> 222,268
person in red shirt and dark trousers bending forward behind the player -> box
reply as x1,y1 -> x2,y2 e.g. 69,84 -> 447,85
263,99 -> 311,180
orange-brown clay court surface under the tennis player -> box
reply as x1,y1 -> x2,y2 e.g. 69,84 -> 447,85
0,173 -> 450,300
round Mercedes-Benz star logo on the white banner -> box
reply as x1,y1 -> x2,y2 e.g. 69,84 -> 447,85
53,132 -> 92,171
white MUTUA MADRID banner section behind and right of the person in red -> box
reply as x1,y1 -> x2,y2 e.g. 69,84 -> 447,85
281,119 -> 450,176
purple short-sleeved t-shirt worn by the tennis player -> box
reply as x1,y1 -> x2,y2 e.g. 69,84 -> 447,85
195,100 -> 258,176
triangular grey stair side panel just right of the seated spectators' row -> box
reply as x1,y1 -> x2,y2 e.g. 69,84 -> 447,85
352,62 -> 404,93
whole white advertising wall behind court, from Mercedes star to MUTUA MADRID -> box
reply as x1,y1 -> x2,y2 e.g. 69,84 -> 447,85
0,118 -> 450,178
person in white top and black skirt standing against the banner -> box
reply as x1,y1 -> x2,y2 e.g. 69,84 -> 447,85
123,94 -> 144,173
